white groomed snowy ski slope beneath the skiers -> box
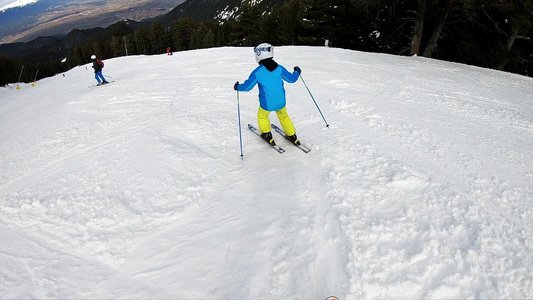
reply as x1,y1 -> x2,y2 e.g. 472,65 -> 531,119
0,47 -> 533,299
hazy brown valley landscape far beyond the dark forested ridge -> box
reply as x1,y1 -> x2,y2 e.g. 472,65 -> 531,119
0,0 -> 185,43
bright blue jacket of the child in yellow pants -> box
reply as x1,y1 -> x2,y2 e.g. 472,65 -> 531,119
237,59 -> 300,111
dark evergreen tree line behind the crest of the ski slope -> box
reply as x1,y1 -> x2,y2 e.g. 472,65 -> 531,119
0,0 -> 533,84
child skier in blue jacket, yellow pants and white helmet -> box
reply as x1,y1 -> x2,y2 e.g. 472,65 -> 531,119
233,43 -> 302,145
